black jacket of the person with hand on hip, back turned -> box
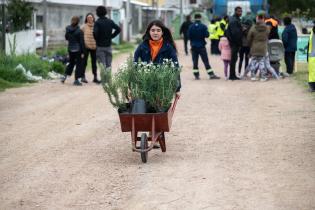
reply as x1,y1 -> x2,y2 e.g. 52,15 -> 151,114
93,17 -> 121,47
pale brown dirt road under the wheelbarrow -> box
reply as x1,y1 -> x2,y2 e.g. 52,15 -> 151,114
0,42 -> 315,210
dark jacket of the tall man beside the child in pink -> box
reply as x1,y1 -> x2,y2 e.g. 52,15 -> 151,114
225,15 -> 243,47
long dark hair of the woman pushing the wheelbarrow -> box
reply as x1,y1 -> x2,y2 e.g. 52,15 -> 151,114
142,20 -> 176,50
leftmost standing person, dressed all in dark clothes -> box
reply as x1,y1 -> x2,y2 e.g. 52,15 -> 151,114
61,16 -> 84,85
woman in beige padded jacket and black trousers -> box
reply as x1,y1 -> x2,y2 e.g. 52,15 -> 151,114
81,13 -> 100,84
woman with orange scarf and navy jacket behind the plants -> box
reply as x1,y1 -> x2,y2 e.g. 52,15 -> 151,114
134,20 -> 181,92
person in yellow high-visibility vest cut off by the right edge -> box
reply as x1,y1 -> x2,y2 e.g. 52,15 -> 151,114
307,21 -> 315,92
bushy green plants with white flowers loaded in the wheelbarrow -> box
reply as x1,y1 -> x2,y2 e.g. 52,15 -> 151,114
101,57 -> 180,113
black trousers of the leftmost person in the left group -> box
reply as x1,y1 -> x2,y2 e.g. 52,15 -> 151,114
65,52 -> 82,80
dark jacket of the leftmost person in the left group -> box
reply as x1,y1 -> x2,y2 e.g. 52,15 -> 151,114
65,25 -> 84,53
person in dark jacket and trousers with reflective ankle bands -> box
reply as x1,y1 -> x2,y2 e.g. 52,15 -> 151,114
188,14 -> 220,80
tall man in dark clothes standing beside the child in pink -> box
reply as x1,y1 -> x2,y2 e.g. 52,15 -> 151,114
226,7 -> 243,80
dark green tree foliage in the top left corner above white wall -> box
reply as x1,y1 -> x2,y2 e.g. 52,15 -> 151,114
7,0 -> 33,32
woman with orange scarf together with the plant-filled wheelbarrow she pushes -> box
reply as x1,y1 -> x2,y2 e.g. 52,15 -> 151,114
102,20 -> 181,163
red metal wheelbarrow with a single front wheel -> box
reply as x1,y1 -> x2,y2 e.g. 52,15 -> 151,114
119,94 -> 179,163
